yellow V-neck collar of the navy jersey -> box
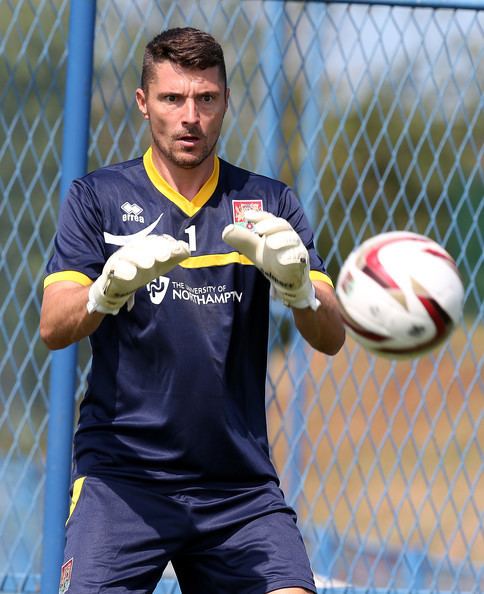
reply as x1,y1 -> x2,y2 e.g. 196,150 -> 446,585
143,146 -> 220,217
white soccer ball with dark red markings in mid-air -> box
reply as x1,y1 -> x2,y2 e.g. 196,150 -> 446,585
336,231 -> 464,359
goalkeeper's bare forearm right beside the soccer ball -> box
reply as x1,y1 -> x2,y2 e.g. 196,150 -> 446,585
292,282 -> 345,355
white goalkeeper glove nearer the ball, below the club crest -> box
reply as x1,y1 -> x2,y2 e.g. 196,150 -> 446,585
222,210 -> 321,311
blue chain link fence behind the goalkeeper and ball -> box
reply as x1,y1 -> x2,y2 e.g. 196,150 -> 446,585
0,0 -> 484,594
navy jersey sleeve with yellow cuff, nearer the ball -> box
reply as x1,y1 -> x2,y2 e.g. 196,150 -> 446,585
277,186 -> 333,285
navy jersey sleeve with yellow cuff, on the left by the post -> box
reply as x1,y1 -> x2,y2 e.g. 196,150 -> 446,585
44,179 -> 106,288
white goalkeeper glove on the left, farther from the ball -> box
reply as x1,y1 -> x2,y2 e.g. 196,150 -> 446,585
87,235 -> 190,315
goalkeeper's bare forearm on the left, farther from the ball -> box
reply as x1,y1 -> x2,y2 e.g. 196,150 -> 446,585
40,281 -> 104,350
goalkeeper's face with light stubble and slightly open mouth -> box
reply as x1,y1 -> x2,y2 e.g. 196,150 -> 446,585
136,61 -> 229,169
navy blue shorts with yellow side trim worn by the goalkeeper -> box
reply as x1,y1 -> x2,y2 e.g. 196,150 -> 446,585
60,477 -> 316,594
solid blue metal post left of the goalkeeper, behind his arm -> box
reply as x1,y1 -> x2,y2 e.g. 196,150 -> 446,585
41,0 -> 96,594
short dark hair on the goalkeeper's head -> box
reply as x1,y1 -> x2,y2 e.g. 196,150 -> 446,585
141,27 -> 227,92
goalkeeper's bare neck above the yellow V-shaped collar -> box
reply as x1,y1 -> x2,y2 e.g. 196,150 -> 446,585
152,146 -> 215,200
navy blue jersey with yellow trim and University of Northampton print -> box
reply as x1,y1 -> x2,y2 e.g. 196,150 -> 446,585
44,149 -> 331,488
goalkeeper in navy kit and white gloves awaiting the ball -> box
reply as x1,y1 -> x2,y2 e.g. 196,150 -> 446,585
40,28 -> 344,594
